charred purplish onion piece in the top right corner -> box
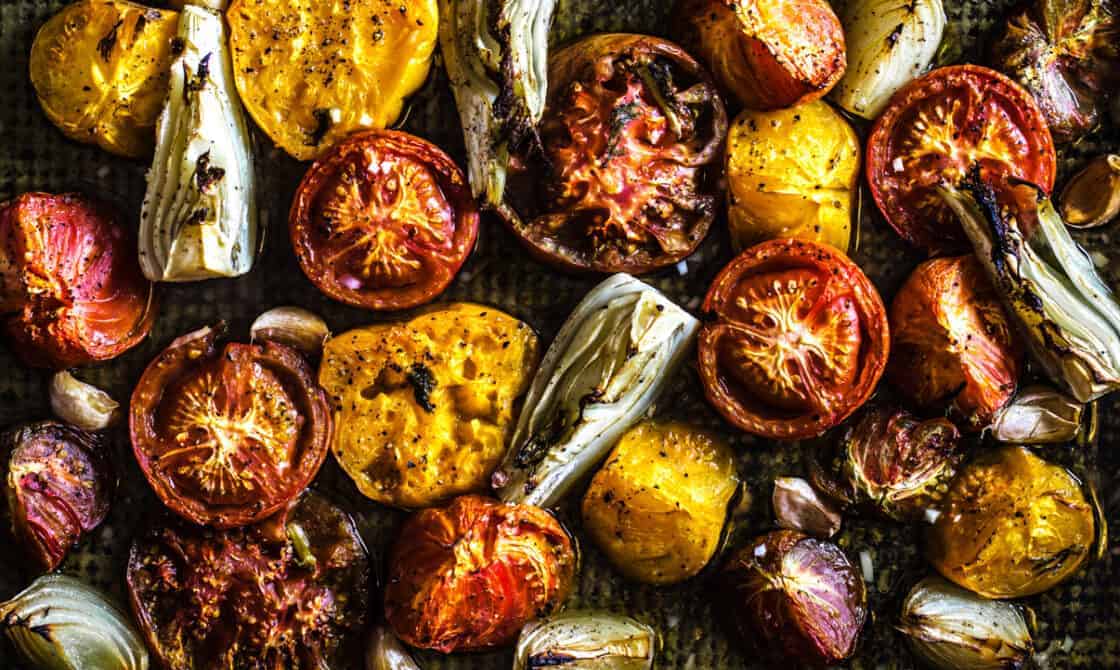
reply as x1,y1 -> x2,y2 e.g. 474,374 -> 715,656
991,0 -> 1120,143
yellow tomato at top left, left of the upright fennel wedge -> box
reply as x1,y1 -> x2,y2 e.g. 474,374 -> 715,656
30,0 -> 179,158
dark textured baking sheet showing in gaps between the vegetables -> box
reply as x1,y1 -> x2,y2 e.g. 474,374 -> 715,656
0,0 -> 1120,670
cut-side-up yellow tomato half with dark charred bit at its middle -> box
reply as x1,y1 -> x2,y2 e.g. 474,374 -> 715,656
319,304 -> 539,508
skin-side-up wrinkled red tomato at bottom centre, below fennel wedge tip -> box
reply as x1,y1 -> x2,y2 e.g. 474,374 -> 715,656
385,495 -> 579,653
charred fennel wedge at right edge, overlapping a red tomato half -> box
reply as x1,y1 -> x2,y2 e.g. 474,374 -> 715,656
939,177 -> 1120,402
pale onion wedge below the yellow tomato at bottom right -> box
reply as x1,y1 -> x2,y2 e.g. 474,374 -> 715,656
896,577 -> 1034,670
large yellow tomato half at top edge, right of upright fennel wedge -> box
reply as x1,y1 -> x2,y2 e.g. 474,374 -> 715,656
226,0 -> 439,160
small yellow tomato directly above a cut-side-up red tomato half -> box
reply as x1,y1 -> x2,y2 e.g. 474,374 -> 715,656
727,100 -> 860,251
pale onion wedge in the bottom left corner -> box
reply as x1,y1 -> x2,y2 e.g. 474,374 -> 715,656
0,575 -> 148,670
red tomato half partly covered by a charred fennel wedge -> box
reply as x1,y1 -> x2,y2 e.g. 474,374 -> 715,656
867,65 -> 1057,253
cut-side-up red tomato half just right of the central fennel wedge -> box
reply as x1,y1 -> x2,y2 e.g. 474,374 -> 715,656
699,240 -> 890,439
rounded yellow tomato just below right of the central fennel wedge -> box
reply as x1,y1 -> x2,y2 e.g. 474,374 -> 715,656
584,421 -> 739,584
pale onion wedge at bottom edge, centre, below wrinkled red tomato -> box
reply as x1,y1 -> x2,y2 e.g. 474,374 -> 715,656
513,612 -> 659,670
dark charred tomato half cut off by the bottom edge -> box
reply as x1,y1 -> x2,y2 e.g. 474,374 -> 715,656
125,493 -> 371,670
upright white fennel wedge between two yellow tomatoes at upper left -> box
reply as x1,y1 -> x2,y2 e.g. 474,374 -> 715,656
140,4 -> 258,281
